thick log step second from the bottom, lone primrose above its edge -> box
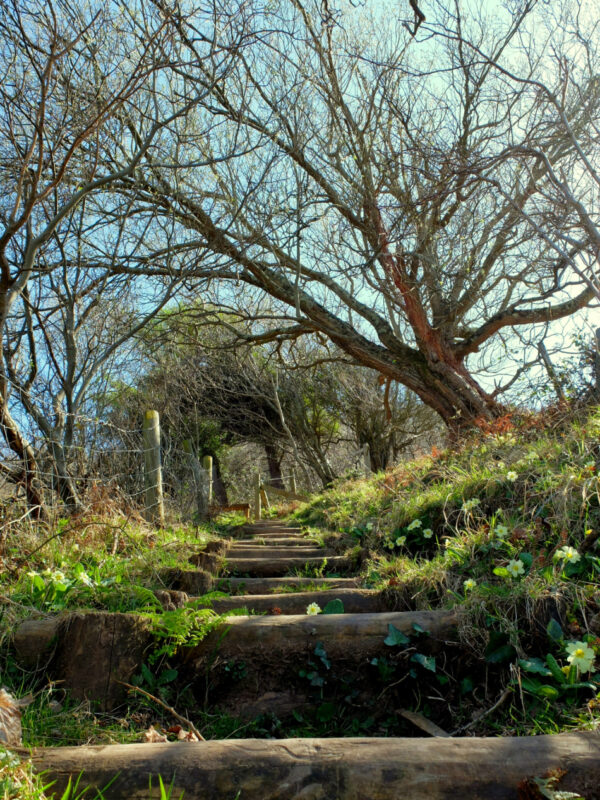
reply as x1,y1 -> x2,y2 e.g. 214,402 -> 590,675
185,608 -> 458,663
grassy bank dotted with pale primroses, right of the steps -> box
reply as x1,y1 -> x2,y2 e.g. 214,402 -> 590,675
294,408 -> 600,735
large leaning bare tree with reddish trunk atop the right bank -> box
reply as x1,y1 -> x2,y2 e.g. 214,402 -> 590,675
116,0 -> 596,428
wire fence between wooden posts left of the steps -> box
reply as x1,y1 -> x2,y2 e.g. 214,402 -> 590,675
0,416 -> 211,531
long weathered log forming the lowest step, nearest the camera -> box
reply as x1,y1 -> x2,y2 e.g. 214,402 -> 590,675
29,732 -> 600,800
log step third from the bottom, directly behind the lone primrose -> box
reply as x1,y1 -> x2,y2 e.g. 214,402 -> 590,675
198,589 -> 389,614
